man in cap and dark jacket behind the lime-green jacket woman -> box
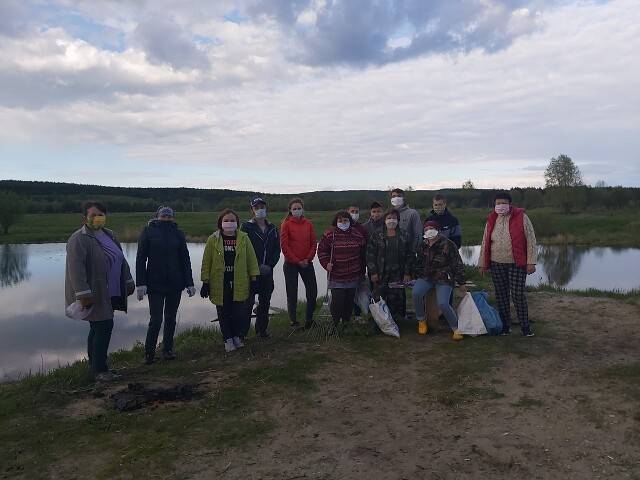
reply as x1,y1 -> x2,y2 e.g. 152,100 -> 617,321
242,197 -> 280,338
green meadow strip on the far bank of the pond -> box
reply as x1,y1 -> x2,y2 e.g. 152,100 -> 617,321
0,208 -> 640,247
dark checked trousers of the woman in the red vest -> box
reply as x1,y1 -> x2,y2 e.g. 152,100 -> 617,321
491,262 -> 531,333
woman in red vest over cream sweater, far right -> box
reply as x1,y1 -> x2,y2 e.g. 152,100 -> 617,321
478,192 -> 537,337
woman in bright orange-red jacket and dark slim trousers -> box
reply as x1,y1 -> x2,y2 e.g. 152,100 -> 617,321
280,198 -> 318,328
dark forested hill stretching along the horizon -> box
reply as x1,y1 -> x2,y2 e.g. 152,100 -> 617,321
0,180 -> 640,213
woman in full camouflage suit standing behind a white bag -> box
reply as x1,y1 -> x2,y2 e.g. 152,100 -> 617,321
367,210 -> 413,320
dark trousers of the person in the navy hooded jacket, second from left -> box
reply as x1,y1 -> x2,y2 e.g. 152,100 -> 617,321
144,291 -> 182,355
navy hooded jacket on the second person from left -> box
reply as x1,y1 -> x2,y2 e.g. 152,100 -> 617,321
136,220 -> 193,293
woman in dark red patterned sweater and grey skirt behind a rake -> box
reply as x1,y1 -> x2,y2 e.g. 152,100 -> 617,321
318,211 -> 367,326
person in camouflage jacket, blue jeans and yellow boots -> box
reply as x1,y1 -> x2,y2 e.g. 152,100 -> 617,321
411,221 -> 466,340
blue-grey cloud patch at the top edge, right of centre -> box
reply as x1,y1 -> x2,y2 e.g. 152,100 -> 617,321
247,0 -> 551,66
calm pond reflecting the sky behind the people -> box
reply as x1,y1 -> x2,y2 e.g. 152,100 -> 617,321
0,243 -> 640,380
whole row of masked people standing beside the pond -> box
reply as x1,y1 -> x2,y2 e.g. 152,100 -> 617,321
65,188 -> 536,380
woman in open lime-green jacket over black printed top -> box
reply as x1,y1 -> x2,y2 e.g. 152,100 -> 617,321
200,209 -> 260,352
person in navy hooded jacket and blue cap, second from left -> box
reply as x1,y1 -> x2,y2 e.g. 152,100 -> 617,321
136,207 -> 196,364
